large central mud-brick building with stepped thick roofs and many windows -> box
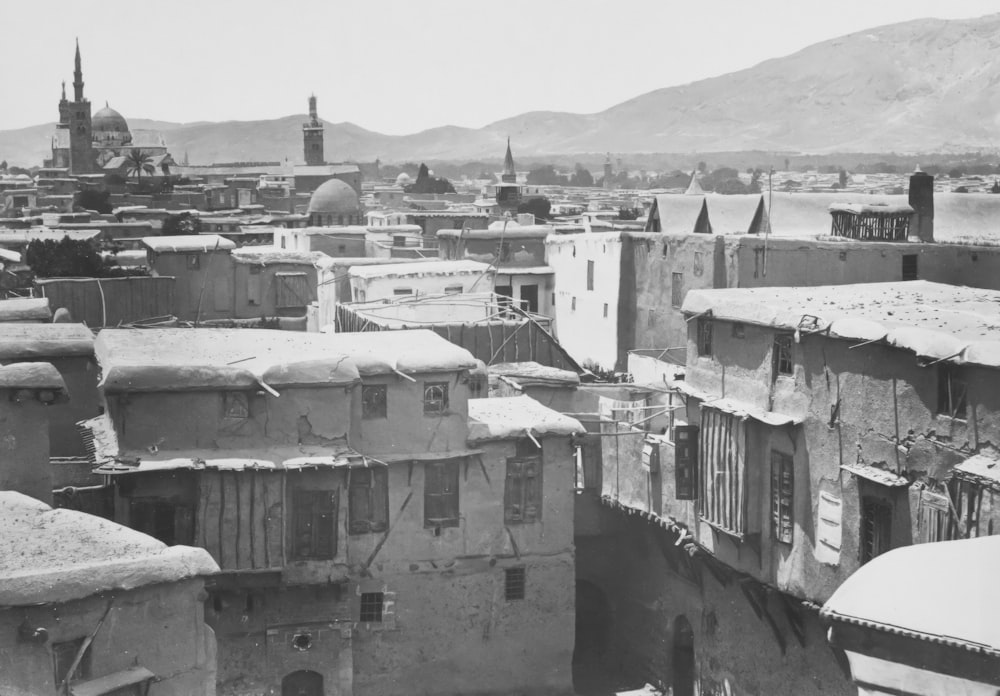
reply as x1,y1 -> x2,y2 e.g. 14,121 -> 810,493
89,329 -> 578,696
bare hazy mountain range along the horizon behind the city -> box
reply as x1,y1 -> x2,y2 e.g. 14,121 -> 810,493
0,14 -> 1000,166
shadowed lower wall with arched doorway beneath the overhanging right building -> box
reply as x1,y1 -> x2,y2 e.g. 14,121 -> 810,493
577,508 -> 856,696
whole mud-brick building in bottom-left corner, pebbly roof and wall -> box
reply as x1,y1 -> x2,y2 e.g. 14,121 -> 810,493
0,490 -> 218,696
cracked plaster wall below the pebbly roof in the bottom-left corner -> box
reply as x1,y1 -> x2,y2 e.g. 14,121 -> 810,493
0,579 -> 216,696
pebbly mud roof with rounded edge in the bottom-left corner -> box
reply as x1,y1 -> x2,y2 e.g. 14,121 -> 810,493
0,491 -> 219,606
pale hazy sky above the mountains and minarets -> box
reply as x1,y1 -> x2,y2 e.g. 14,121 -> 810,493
0,0 -> 1000,134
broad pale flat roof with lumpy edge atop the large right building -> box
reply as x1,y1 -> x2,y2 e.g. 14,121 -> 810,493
682,280 -> 1000,367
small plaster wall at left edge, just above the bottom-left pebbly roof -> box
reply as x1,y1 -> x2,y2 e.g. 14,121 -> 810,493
0,389 -> 52,505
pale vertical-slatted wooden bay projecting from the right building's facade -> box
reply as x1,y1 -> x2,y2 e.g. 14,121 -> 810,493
698,405 -> 747,538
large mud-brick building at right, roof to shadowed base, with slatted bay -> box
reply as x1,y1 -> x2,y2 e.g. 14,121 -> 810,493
580,281 -> 1000,694
